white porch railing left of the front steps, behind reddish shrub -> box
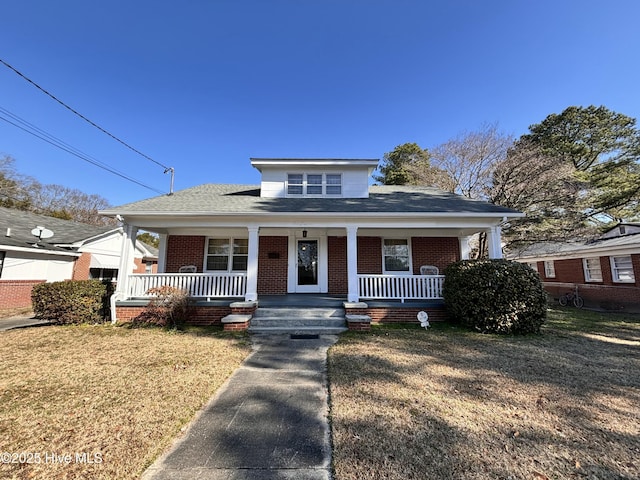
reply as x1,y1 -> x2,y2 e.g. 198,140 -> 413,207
127,273 -> 247,298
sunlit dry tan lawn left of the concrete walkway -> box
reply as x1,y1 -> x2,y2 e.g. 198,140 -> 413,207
0,326 -> 249,479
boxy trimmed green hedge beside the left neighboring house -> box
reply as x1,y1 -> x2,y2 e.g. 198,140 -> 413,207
31,280 -> 112,325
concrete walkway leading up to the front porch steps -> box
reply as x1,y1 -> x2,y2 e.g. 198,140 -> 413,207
142,335 -> 337,480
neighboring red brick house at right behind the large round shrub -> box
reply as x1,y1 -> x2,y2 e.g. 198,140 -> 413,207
510,223 -> 640,312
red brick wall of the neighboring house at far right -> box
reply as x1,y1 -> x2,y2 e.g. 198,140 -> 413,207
538,255 -> 640,311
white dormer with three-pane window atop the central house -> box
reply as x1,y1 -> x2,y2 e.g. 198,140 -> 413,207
251,158 -> 378,198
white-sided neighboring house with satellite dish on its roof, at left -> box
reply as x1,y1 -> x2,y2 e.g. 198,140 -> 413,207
0,207 -> 157,309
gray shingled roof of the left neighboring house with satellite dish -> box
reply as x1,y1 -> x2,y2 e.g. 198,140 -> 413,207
0,207 -> 116,251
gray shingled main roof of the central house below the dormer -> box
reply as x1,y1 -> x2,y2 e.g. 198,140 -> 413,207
103,184 -> 518,215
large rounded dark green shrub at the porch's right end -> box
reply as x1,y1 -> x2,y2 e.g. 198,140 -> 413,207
444,260 -> 547,333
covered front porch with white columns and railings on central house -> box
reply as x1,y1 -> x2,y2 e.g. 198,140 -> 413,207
116,220 -> 502,302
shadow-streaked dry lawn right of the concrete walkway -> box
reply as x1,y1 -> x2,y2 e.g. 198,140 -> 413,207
329,310 -> 640,480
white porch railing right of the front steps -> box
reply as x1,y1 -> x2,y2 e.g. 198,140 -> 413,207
358,275 -> 444,302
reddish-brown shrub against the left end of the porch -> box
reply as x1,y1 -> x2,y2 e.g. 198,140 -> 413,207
133,285 -> 189,329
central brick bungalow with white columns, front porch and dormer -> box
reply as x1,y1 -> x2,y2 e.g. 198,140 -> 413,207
102,158 -> 522,331
